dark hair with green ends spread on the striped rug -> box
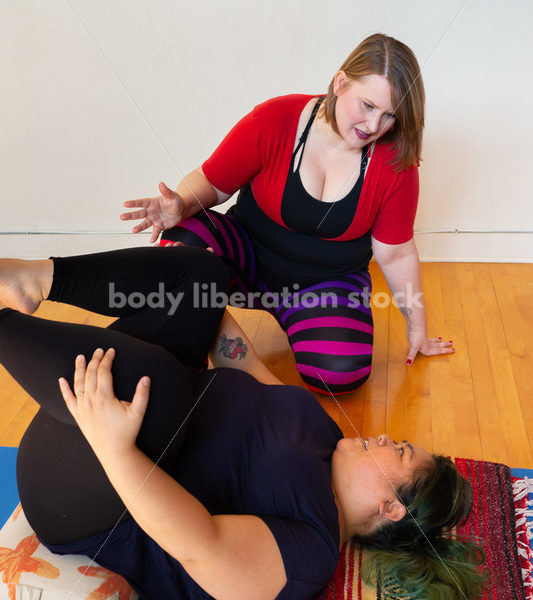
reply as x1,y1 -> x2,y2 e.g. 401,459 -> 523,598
354,455 -> 486,600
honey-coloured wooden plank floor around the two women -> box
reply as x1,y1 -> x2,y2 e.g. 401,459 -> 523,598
0,263 -> 533,468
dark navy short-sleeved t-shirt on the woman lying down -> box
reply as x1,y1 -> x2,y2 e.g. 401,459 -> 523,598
46,368 -> 342,600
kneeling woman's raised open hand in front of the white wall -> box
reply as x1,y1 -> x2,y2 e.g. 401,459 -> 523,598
120,182 -> 184,244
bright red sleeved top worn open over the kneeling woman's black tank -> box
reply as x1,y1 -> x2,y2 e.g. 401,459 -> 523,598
202,94 -> 419,244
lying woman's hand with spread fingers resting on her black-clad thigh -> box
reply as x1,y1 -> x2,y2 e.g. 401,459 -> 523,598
59,348 -> 150,462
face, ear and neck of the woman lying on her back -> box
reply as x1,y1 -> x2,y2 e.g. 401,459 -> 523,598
332,434 -> 434,536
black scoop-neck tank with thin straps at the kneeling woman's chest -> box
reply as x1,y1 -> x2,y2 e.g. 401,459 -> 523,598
281,98 -> 368,239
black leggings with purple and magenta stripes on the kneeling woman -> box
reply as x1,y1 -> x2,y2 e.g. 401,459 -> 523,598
161,210 -> 374,394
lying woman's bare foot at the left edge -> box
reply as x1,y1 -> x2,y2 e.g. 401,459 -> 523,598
0,258 -> 51,315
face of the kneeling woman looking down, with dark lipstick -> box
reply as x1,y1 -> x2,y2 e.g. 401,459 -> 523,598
333,71 -> 396,148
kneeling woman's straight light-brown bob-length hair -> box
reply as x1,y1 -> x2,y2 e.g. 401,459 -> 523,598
321,33 -> 425,171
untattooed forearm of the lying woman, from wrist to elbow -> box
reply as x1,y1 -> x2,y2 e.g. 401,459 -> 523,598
98,447 -> 218,562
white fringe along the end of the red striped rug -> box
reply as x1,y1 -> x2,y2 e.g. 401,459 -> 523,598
513,477 -> 533,600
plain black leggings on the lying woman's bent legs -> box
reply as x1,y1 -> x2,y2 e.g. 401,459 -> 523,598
0,247 -> 230,544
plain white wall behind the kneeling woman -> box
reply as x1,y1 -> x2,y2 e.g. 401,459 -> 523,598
0,0 -> 533,261
